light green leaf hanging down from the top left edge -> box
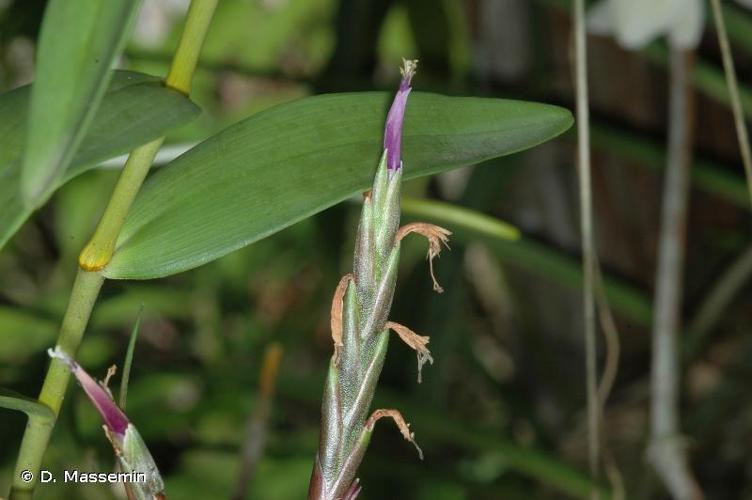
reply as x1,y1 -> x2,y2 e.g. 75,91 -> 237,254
21,0 -> 141,207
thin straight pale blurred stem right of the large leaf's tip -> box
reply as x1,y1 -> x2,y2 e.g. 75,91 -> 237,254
572,0 -> 600,499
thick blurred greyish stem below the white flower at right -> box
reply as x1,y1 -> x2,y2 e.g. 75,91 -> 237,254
648,50 -> 703,500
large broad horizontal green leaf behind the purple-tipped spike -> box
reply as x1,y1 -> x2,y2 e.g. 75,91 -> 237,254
104,92 -> 572,279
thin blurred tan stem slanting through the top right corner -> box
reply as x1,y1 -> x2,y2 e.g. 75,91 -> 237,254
710,0 -> 752,209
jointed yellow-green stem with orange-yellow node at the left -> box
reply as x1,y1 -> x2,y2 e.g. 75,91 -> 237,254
10,0 -> 218,500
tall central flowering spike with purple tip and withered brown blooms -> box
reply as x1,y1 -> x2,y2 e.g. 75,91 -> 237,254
308,61 -> 432,500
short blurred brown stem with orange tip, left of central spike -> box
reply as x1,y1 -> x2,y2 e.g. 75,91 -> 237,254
230,342 -> 283,500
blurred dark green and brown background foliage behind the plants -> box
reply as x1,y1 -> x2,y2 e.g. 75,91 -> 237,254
0,0 -> 752,500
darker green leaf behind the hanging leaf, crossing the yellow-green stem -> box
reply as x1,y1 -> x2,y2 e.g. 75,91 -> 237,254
0,71 -> 200,248
